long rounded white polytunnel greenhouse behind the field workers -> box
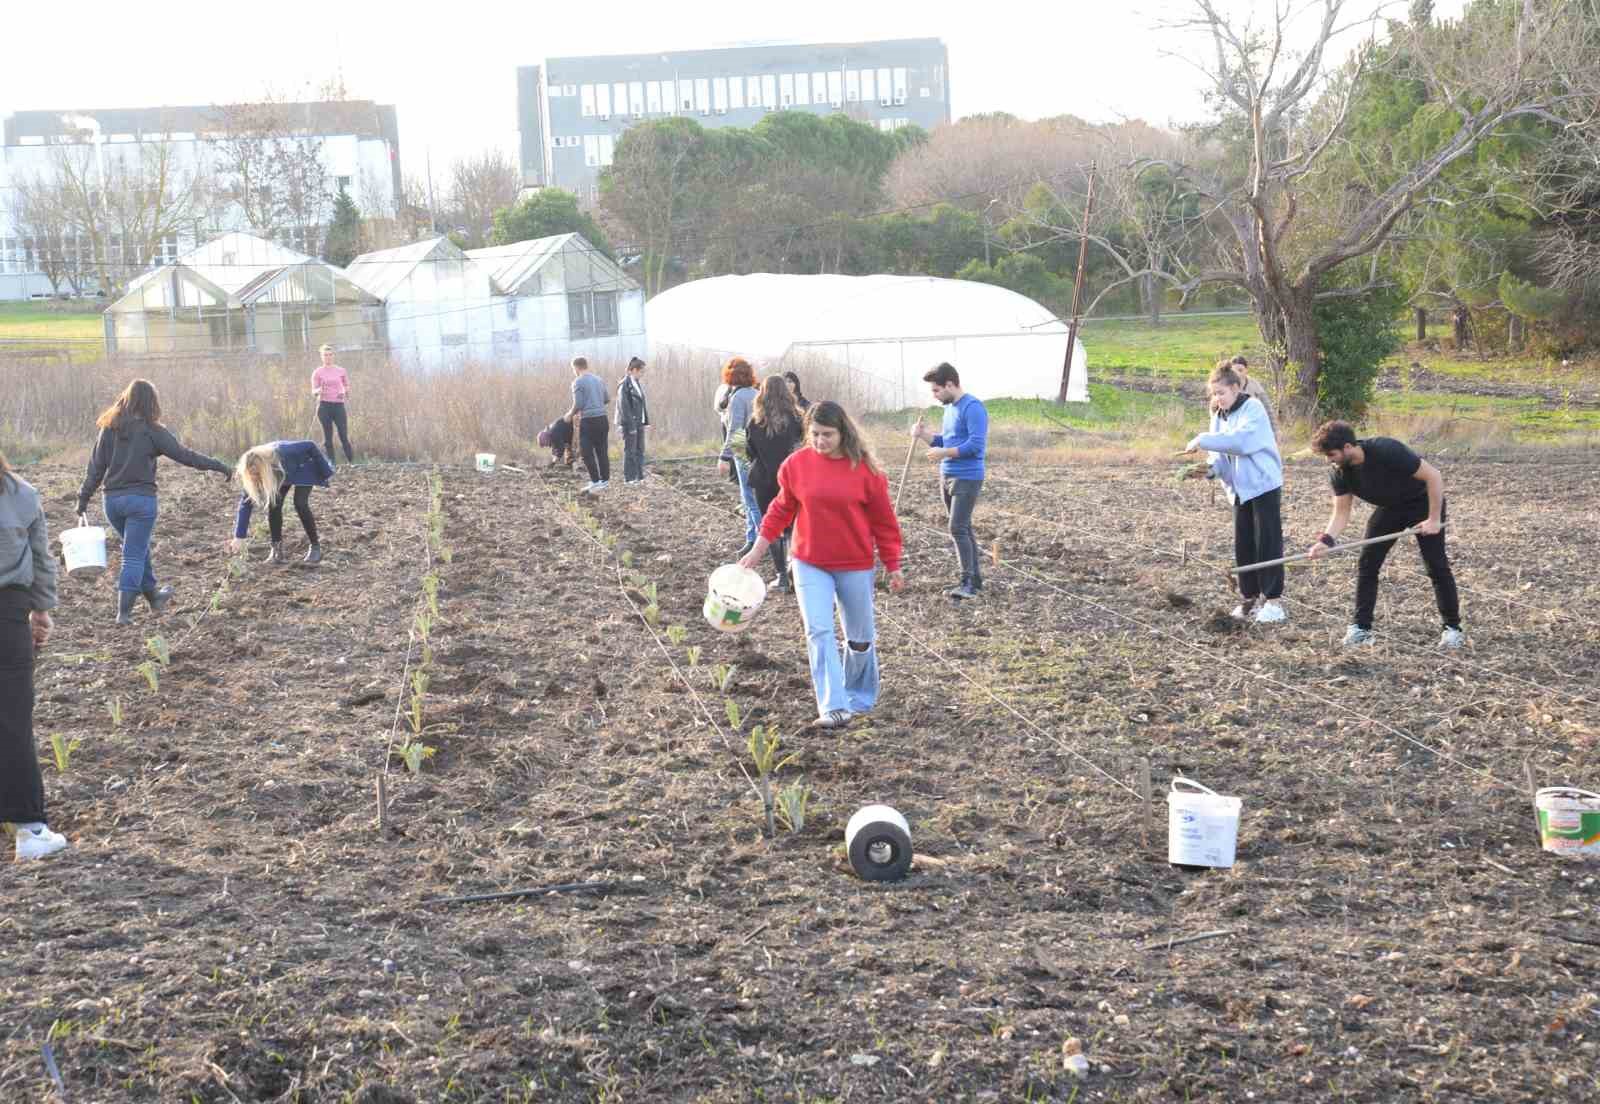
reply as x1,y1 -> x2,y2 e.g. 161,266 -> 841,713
646,274 -> 1088,410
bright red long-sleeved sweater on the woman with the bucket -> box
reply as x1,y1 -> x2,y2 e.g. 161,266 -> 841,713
762,448 -> 901,571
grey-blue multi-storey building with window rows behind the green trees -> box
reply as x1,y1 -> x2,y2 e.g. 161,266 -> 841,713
517,38 -> 950,203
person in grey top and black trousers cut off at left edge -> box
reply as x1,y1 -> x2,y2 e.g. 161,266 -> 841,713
0,454 -> 67,859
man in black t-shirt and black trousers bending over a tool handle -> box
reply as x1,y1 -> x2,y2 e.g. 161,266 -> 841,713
1309,422 -> 1466,648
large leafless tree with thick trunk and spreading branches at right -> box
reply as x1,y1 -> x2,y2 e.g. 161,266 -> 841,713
1146,0 -> 1600,408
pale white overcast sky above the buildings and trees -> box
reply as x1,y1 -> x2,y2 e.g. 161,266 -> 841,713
0,0 -> 1464,174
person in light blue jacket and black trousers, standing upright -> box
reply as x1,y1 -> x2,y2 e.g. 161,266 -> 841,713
1189,360 -> 1285,624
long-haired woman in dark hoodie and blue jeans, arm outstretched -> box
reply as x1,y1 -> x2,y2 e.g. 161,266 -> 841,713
78,379 -> 232,626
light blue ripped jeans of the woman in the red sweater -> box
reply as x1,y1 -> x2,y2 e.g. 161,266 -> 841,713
794,560 -> 878,715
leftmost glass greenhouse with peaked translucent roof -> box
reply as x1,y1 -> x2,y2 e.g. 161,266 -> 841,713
106,234 -> 382,355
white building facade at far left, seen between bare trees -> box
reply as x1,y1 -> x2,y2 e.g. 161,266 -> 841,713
0,101 -> 400,299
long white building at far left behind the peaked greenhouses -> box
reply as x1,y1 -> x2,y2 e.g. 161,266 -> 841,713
0,101 -> 402,299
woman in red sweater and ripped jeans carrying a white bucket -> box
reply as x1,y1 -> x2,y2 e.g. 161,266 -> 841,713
739,402 -> 906,728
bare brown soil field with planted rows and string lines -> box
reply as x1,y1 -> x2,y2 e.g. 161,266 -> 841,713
0,458 -> 1600,1104
